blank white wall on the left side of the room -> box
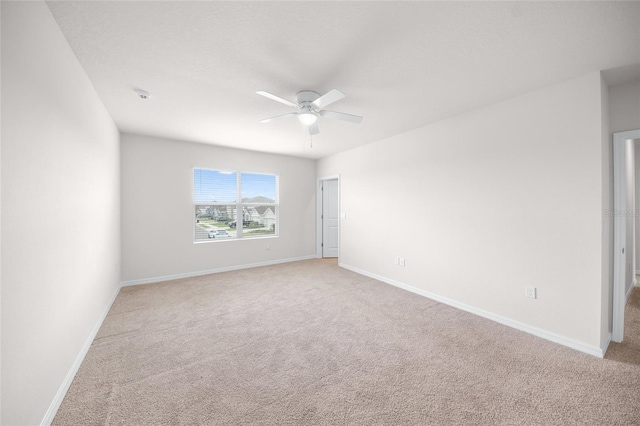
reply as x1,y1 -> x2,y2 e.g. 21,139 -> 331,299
1,2 -> 120,425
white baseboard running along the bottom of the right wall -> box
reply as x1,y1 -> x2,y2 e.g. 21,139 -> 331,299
339,263 -> 608,358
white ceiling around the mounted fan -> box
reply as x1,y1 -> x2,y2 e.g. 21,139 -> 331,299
48,1 -> 640,158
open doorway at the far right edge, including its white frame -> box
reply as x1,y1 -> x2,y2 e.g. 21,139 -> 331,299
611,129 -> 640,342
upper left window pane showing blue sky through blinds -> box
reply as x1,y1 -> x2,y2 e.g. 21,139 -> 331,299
193,169 -> 238,203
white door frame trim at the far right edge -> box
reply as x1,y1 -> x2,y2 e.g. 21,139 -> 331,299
611,129 -> 640,342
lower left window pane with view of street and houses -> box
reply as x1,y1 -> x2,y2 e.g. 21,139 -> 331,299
194,204 -> 237,241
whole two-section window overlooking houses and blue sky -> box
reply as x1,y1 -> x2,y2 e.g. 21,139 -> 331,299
193,169 -> 278,242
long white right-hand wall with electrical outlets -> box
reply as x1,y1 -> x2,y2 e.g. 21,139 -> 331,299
318,73 -> 608,350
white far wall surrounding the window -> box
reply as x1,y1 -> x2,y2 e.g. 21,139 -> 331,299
121,134 -> 316,283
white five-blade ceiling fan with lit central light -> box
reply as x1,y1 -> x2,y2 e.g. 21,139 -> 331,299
256,89 -> 362,135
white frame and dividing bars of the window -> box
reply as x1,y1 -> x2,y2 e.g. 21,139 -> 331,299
191,167 -> 280,244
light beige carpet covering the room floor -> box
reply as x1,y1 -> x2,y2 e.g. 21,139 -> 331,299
54,259 -> 640,425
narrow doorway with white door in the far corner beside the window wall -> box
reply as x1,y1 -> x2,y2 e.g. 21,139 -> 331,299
317,177 -> 340,257
